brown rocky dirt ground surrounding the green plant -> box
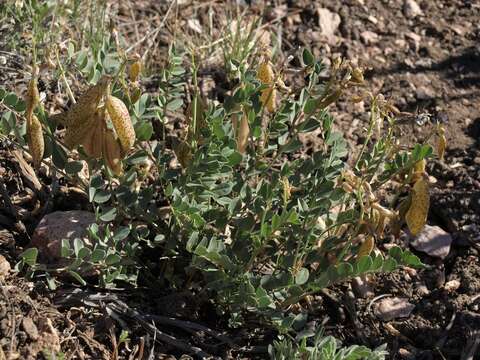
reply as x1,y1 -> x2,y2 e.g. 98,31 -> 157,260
0,0 -> 480,360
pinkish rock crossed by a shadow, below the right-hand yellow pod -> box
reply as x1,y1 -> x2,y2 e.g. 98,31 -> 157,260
411,225 -> 453,259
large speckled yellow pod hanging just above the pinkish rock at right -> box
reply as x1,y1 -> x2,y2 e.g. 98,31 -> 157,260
405,177 -> 430,236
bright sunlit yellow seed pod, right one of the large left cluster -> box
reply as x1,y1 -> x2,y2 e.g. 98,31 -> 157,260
105,95 -> 135,154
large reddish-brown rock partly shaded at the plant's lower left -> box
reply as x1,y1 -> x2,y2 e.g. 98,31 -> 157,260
30,210 -> 95,261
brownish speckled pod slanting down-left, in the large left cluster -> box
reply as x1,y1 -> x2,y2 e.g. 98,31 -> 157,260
50,75 -> 111,127
